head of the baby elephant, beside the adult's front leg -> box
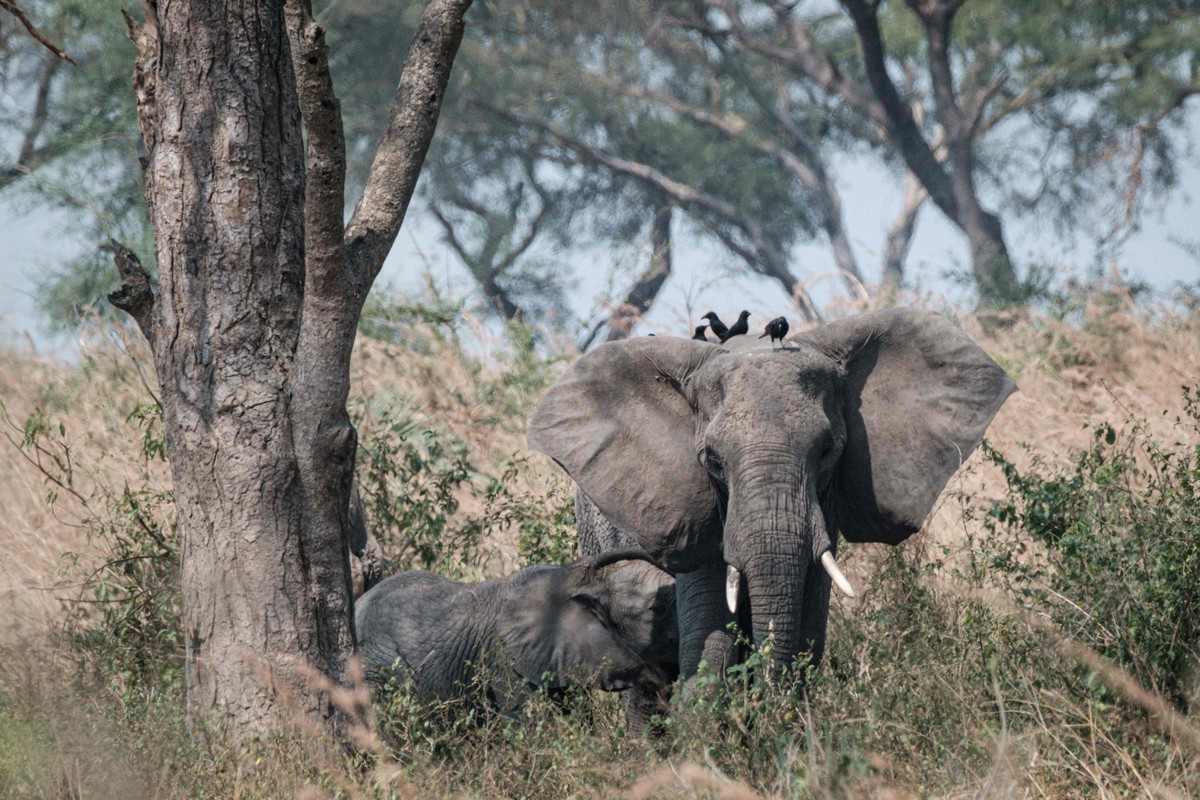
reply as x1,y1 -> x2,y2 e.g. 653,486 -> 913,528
498,552 -> 676,691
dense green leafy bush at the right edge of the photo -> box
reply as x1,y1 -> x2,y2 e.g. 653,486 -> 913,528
984,387 -> 1200,709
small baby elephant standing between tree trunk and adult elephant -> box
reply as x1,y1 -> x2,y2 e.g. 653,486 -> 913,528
354,551 -> 678,710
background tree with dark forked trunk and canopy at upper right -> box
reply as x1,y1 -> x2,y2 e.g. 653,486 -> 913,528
670,0 -> 1200,305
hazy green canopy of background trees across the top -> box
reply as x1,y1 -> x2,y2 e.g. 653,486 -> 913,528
0,0 -> 1200,333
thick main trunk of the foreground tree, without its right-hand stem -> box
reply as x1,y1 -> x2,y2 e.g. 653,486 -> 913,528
132,2 -> 324,733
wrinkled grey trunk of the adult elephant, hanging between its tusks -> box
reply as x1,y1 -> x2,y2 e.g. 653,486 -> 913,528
725,459 -> 829,666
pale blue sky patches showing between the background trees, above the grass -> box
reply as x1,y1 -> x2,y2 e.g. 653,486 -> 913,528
0,112 -> 1200,345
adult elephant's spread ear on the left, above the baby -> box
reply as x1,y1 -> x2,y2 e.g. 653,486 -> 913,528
528,336 -> 725,569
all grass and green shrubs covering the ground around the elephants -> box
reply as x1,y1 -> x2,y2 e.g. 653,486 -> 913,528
0,291 -> 1200,798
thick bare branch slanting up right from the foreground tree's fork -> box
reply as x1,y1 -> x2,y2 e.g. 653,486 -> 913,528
346,0 -> 472,287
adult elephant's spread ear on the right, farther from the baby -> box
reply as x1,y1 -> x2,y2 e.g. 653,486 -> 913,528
796,308 -> 1016,545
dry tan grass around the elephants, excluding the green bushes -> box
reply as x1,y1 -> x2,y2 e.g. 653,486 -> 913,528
0,293 -> 1200,799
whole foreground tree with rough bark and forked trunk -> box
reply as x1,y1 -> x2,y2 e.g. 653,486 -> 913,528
109,0 -> 470,738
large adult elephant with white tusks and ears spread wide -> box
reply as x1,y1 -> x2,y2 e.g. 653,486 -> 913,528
528,308 -> 1016,675
